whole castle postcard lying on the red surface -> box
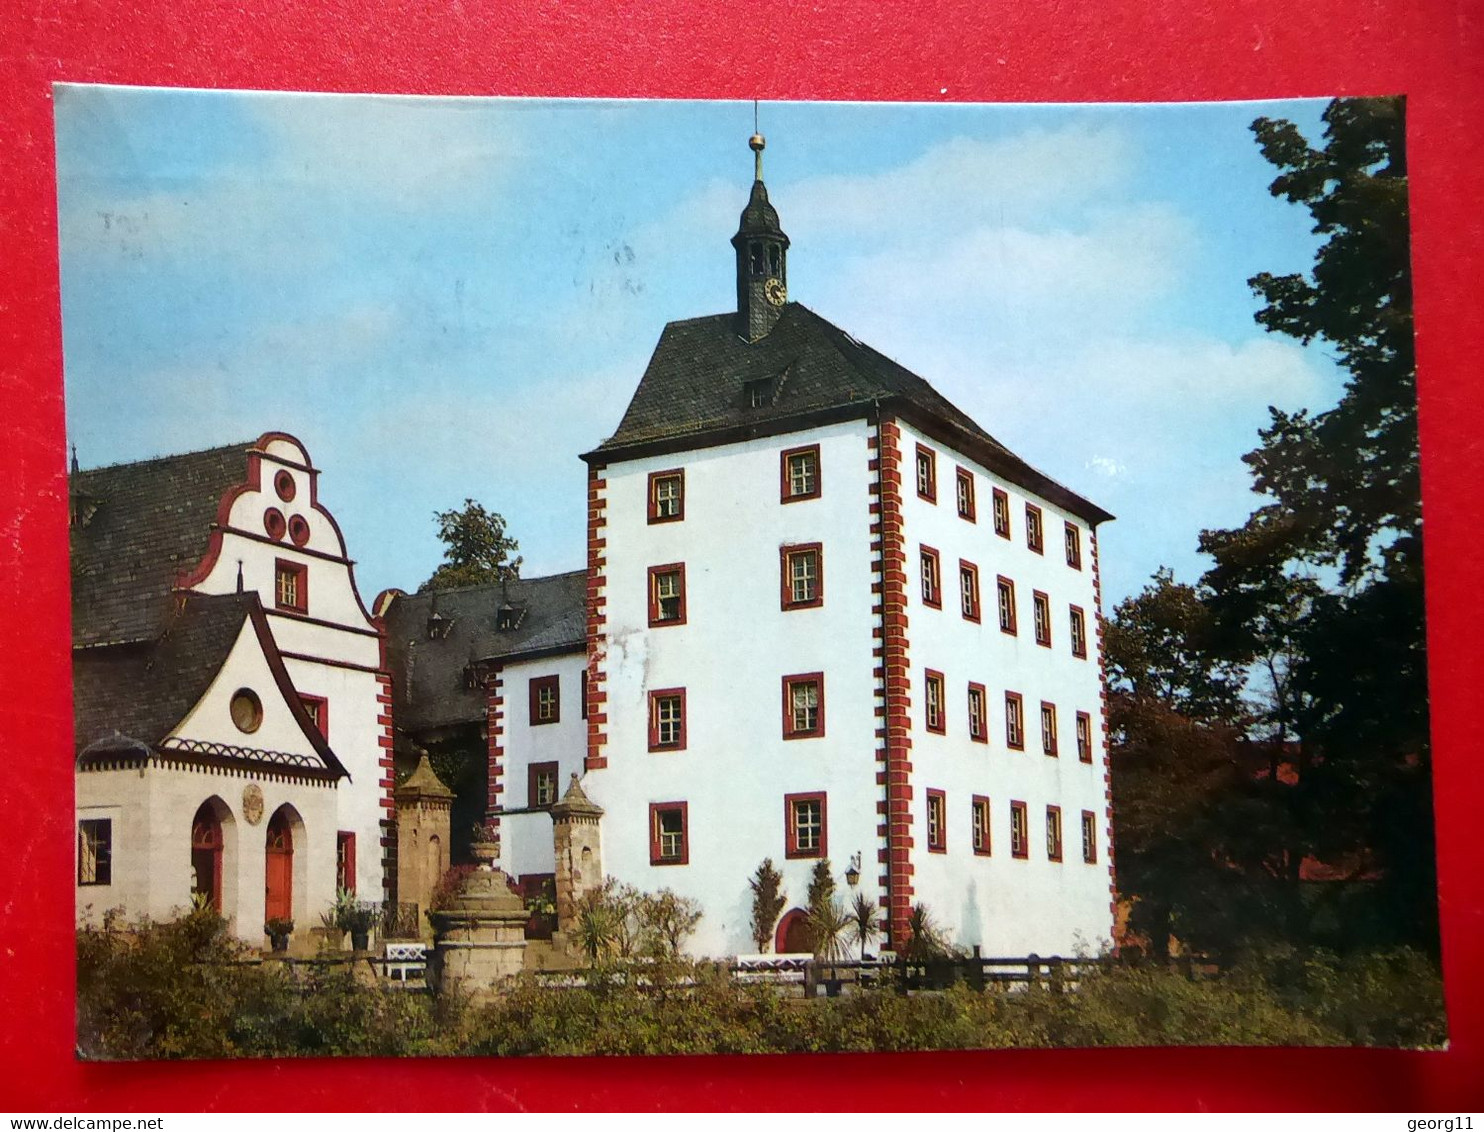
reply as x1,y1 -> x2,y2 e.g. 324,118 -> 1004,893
56,85 -> 1447,1059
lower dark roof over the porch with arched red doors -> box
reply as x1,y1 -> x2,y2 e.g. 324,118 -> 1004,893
73,590 -> 346,777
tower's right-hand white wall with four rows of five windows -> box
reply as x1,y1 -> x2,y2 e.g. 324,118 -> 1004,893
901,424 -> 1113,955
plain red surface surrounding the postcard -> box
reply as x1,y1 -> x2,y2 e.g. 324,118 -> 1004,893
0,0 -> 1484,1111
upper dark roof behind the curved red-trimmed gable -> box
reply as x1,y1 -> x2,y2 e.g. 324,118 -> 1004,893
68,441 -> 252,645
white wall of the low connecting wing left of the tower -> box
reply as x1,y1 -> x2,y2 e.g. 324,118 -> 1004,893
500,651 -> 588,877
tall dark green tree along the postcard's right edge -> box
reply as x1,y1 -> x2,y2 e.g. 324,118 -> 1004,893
1201,98 -> 1437,947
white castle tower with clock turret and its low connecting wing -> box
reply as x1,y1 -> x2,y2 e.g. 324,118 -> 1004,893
386,138 -> 1113,955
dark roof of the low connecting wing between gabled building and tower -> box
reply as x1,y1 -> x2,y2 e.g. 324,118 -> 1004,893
386,570 -> 588,733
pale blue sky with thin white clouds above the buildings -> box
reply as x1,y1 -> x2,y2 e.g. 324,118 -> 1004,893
56,86 -> 1340,608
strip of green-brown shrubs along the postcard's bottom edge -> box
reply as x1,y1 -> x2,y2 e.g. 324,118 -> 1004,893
77,907 -> 1447,1059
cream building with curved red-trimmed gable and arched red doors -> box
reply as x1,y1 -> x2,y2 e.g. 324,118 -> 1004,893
70,433 -> 393,942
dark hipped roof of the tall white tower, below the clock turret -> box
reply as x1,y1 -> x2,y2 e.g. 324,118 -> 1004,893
585,303 -> 1112,522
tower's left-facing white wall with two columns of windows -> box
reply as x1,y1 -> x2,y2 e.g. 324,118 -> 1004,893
583,421 -> 880,955
